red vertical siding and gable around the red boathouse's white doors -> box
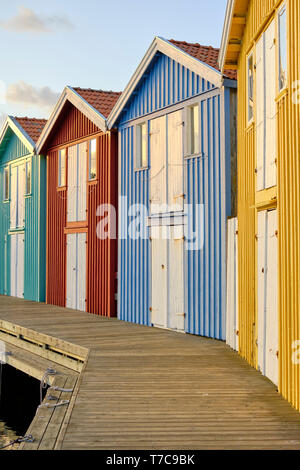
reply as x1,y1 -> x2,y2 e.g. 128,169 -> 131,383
46,101 -> 118,317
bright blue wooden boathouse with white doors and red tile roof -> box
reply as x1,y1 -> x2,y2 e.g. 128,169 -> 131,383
108,37 -> 236,339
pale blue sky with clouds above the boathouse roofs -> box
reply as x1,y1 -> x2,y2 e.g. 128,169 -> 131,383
0,0 -> 227,125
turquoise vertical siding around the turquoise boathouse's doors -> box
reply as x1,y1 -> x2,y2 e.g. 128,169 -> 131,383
0,130 -> 46,302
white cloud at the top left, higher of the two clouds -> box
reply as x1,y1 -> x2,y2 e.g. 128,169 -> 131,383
0,6 -> 73,33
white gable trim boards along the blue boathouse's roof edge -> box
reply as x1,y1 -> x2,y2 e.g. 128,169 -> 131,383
107,37 -> 223,129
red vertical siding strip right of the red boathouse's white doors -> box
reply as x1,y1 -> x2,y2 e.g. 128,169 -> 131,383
87,132 -> 118,317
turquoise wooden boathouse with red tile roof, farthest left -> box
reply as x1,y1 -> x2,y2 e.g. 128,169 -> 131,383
0,116 -> 46,302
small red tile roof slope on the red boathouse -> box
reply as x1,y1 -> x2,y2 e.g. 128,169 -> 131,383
73,87 -> 121,118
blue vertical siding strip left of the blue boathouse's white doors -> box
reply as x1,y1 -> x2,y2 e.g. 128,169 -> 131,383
118,127 -> 151,325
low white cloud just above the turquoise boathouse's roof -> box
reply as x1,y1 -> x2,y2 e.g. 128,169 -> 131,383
6,81 -> 60,111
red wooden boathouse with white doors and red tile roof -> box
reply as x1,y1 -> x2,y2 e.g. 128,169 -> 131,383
37,87 -> 120,317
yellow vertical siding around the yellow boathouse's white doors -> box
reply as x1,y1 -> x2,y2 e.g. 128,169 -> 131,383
238,0 -> 300,409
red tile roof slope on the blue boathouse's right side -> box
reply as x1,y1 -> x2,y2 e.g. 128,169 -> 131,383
169,39 -> 237,80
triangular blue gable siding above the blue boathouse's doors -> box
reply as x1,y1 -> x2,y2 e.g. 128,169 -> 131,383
121,53 -> 214,122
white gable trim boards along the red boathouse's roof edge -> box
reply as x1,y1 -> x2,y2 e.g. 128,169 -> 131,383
36,86 -> 107,153
